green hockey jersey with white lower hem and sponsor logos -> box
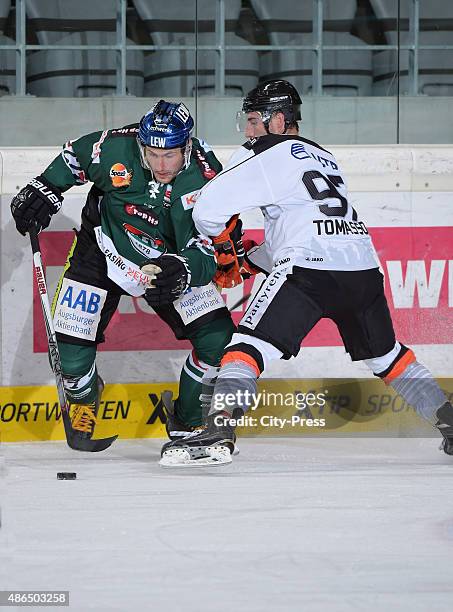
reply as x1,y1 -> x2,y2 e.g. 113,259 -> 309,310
43,125 -> 222,295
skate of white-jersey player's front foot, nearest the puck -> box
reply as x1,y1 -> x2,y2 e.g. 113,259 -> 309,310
159,413 -> 236,467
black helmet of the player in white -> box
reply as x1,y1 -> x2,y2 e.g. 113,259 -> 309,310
242,79 -> 302,129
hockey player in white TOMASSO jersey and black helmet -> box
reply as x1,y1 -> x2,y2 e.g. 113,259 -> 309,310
161,80 -> 453,465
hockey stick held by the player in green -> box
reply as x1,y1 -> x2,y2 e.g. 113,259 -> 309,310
29,226 -> 118,453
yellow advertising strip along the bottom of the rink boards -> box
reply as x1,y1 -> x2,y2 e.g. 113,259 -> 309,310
0,378 -> 453,442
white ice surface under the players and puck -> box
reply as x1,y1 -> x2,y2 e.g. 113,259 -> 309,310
0,438 -> 453,612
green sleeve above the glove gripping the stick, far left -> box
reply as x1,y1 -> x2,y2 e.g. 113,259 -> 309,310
43,132 -> 107,191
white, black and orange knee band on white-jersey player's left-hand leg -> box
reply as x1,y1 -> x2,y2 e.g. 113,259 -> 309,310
220,333 -> 283,376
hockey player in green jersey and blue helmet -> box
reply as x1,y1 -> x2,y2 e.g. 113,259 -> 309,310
11,100 -> 234,444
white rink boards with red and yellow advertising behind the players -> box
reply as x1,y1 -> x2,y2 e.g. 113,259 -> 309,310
0,145 -> 453,441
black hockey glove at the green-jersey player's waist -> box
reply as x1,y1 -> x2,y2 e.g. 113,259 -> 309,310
142,254 -> 191,307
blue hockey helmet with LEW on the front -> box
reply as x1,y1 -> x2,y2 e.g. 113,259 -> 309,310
138,100 -> 194,149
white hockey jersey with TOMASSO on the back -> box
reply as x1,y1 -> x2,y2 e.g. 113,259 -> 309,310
193,134 -> 379,270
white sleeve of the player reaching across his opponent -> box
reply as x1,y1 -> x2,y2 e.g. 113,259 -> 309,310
193,149 -> 274,236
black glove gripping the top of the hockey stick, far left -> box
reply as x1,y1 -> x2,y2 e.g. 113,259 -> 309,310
11,176 -> 63,236
